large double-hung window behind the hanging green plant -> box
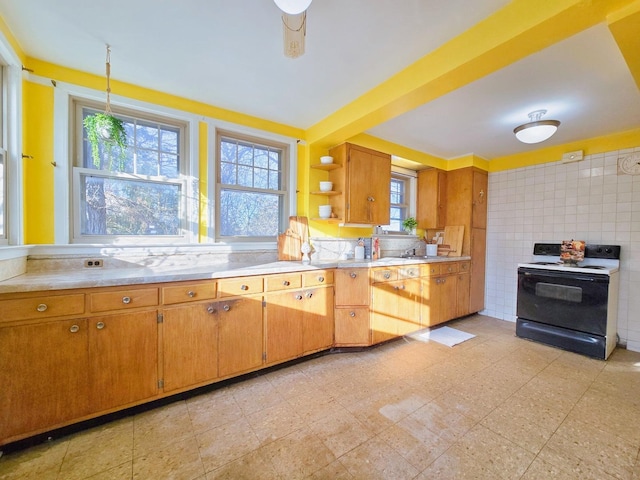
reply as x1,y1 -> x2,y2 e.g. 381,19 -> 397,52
73,102 -> 187,242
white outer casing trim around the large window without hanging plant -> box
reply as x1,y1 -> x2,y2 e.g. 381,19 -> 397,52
206,118 -> 298,244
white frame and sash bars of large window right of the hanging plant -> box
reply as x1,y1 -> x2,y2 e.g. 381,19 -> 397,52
211,125 -> 296,244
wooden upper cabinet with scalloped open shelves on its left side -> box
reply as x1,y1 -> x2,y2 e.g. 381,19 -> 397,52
329,143 -> 391,225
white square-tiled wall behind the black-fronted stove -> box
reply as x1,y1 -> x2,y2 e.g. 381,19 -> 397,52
482,147 -> 640,351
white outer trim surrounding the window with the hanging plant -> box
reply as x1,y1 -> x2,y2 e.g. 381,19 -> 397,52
44,76 -> 199,245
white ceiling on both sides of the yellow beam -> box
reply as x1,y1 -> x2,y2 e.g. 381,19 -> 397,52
0,0 -> 640,159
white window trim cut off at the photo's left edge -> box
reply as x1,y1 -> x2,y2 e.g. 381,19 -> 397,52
0,32 -> 24,246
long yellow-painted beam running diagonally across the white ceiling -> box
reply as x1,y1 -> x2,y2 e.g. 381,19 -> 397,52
305,0 -> 638,148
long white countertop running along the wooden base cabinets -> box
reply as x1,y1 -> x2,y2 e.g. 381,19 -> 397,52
0,257 -> 471,293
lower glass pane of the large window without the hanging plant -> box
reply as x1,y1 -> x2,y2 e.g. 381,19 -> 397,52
220,190 -> 282,237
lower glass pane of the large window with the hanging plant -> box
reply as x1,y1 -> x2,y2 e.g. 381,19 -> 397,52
80,174 -> 182,235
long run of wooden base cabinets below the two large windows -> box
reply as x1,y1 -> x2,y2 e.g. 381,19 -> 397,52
0,270 -> 334,445
